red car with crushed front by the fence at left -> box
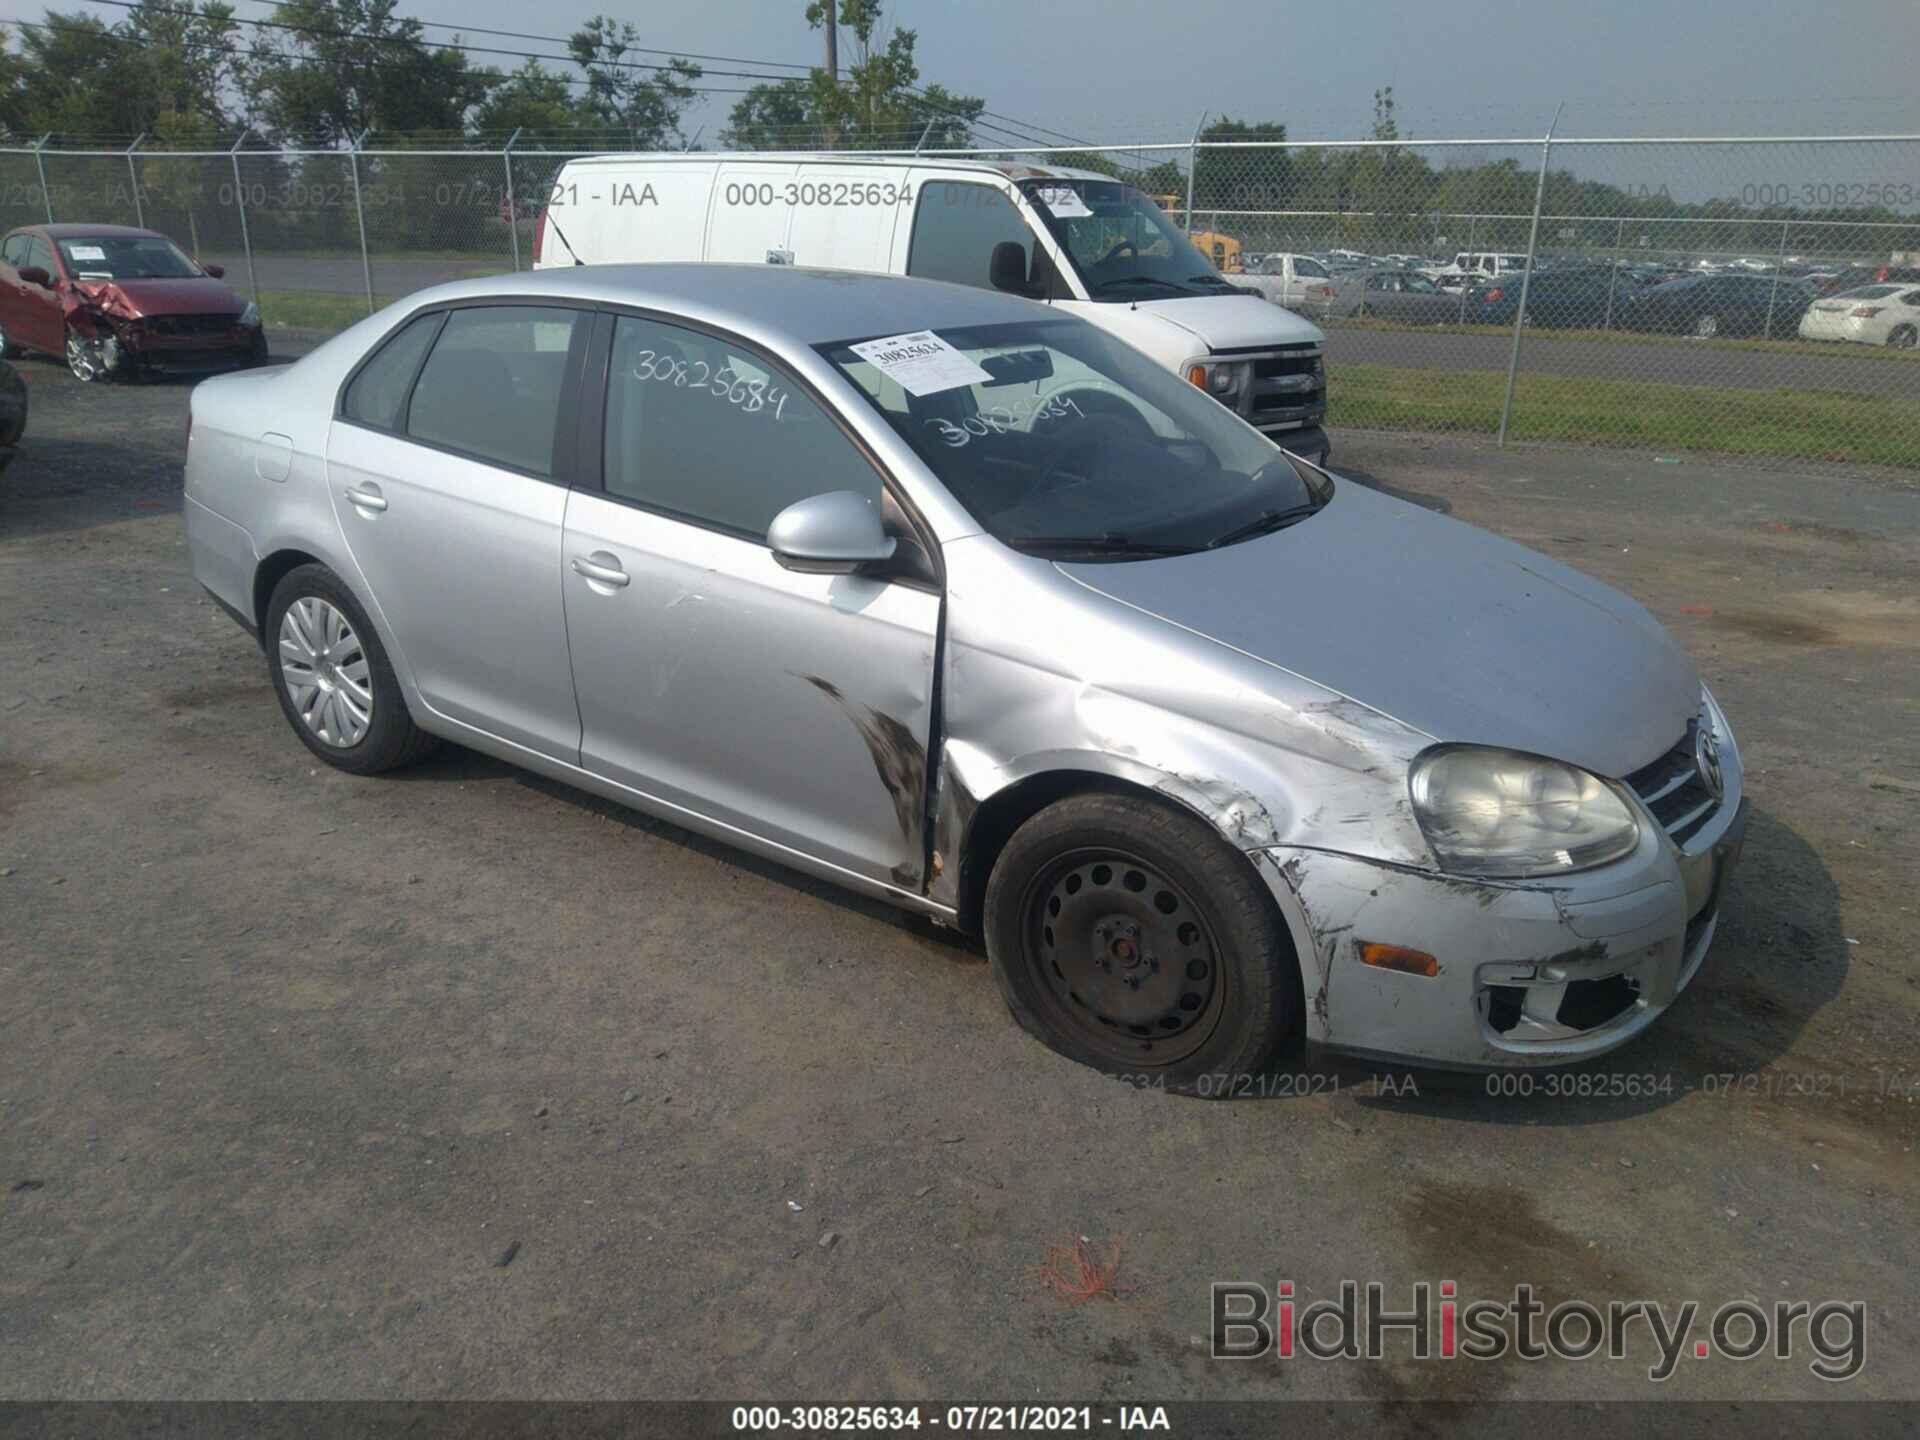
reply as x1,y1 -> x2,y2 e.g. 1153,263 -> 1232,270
0,225 -> 267,380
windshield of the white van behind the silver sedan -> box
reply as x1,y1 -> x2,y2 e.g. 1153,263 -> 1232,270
1021,180 -> 1233,301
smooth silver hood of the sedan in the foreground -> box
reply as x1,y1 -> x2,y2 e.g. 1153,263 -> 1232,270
1058,480 -> 1699,778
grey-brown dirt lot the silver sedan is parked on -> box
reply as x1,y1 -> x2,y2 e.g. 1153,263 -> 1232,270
0,361 -> 1920,1402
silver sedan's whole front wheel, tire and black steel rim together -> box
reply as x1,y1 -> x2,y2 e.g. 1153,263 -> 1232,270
983,793 -> 1300,1096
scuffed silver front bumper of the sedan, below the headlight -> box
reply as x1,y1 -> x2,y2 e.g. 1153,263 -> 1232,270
1258,791 -> 1747,1069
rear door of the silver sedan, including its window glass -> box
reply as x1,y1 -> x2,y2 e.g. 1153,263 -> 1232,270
326,301 -> 591,762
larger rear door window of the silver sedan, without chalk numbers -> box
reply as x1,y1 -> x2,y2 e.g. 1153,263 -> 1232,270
407,305 -> 578,476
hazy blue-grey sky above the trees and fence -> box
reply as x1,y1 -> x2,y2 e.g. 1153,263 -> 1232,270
408,0 -> 1920,144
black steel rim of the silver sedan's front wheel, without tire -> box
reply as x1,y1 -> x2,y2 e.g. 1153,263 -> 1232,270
1025,851 -> 1227,1066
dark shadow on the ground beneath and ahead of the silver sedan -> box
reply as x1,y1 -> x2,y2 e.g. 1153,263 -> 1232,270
390,745 -> 1847,1125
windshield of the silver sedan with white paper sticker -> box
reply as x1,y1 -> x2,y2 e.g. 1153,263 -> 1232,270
820,319 -> 1332,561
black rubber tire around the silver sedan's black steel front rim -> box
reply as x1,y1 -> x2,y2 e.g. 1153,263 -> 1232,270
983,793 -> 1300,1094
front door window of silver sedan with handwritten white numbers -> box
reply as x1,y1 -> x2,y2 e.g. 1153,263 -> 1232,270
605,315 -> 881,543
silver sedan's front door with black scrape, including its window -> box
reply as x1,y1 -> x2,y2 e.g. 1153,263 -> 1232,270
564,315 -> 941,891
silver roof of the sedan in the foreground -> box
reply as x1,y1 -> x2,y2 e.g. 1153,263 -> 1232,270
409,261 -> 1069,346
